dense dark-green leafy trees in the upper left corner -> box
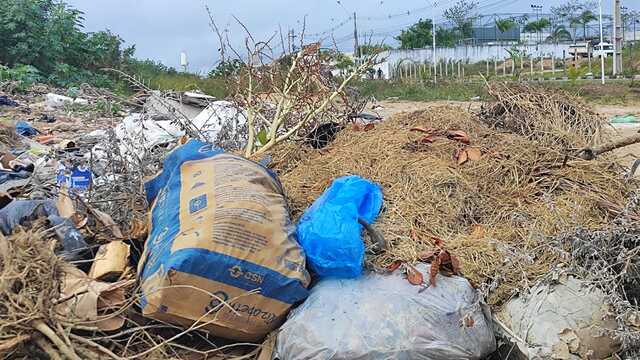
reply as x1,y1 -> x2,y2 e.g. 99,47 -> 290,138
0,0 -> 181,86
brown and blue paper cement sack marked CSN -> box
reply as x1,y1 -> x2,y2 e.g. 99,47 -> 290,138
138,140 -> 309,341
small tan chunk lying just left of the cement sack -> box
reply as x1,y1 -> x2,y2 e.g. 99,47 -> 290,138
89,241 -> 130,281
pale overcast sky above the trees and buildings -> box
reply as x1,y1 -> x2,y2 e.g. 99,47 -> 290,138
66,0 -> 640,72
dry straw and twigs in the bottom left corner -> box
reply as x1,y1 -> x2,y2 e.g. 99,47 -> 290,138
0,223 -> 261,360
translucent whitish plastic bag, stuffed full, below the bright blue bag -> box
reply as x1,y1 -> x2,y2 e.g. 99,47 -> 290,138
276,264 -> 496,360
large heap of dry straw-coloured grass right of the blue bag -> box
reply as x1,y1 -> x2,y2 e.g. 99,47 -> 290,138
272,103 -> 629,303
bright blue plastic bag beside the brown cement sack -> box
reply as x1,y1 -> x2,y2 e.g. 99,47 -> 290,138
297,176 -> 382,278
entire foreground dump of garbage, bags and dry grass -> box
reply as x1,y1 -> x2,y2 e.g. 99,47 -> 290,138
0,82 -> 640,360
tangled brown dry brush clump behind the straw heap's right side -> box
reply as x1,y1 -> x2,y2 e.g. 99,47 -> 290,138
480,83 -> 606,149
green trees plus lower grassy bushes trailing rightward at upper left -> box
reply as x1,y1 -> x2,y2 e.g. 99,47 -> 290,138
0,0 -> 228,96
